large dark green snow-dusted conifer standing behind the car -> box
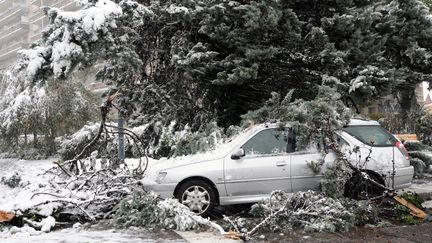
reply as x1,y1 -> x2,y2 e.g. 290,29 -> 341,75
3,0 -> 432,143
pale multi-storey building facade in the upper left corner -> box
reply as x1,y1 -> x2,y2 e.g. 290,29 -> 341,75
0,0 -> 78,70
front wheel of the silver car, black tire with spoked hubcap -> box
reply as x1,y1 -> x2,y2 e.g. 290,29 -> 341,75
175,180 -> 216,217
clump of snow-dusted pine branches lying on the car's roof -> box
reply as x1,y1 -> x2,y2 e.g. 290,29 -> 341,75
242,85 -> 352,150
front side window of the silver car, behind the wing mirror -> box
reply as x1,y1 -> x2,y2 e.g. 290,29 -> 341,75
242,128 -> 288,156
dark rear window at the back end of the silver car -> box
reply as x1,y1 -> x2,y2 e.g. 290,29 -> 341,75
343,126 -> 397,147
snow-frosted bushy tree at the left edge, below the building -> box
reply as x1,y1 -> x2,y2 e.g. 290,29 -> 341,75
0,75 -> 95,159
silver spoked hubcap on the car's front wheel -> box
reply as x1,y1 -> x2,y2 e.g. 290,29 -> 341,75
182,186 -> 210,214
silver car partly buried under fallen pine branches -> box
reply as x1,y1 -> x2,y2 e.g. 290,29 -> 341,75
143,119 -> 414,215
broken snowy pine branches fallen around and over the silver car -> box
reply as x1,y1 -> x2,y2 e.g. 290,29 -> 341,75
0,88 -> 426,240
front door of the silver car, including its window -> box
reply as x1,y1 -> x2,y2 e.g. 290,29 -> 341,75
224,128 -> 291,196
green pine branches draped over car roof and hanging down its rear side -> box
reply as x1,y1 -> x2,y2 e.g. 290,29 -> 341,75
243,86 -> 353,198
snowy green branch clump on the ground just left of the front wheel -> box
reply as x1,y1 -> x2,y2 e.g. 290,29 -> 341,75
113,192 -> 205,231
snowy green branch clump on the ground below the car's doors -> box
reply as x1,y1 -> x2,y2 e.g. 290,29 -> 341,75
251,191 -> 376,232
